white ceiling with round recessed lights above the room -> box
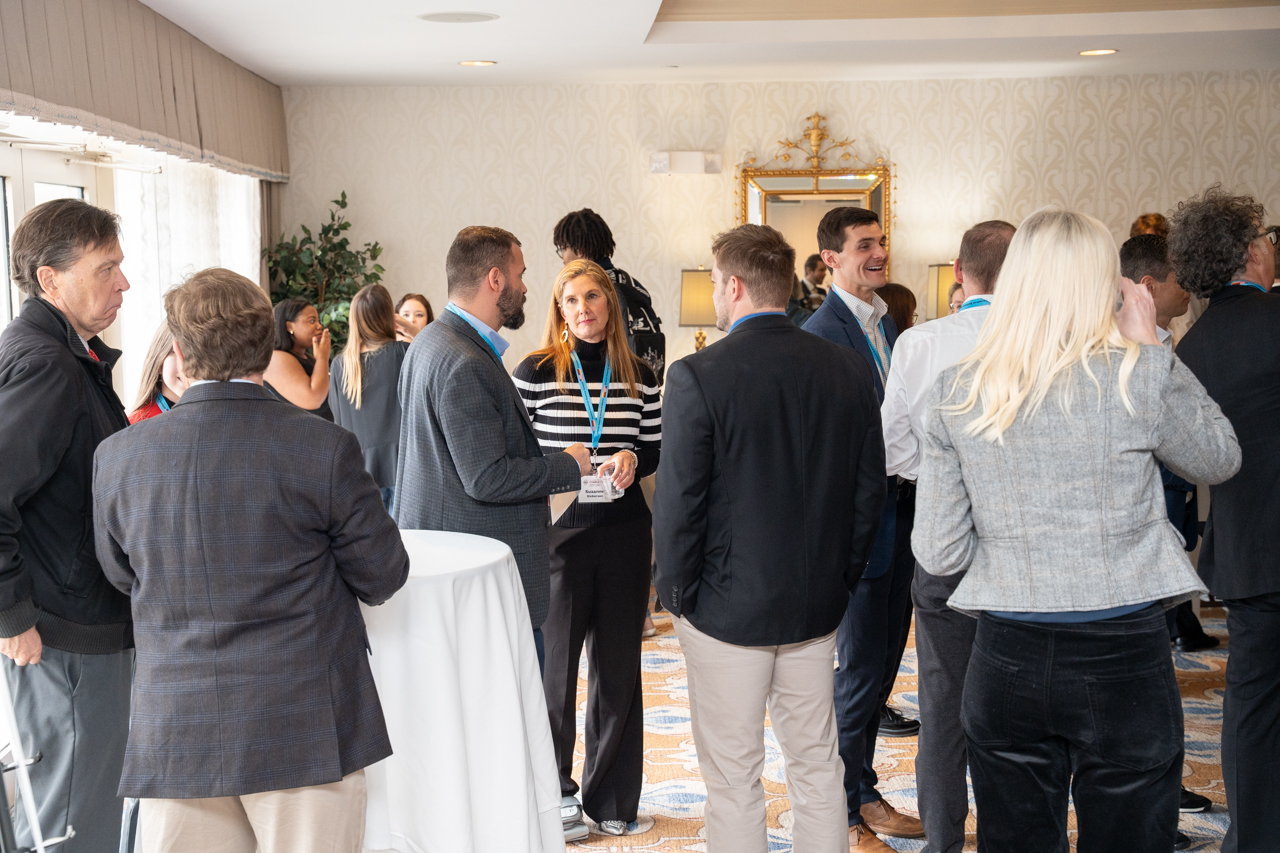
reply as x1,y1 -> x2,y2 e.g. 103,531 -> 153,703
143,0 -> 1280,86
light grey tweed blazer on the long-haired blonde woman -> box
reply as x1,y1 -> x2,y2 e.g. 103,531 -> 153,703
911,346 -> 1240,612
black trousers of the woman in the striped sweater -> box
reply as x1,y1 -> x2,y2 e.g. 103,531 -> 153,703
543,517 -> 653,822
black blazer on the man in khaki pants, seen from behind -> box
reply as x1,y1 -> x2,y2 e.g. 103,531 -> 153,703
653,314 -> 884,646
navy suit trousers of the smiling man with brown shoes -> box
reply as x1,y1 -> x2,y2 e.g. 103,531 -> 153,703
835,514 -> 914,826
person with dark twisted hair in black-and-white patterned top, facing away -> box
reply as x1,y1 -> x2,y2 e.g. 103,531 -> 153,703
552,207 -> 667,386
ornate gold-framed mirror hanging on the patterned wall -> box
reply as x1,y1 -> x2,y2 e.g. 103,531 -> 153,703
736,113 -> 893,275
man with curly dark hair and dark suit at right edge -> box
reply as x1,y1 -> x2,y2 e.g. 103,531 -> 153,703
1169,186 -> 1280,853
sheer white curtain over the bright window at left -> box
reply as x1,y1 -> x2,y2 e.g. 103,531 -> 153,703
115,154 -> 261,409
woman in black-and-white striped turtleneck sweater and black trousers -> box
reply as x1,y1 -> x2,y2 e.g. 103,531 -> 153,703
515,260 -> 662,838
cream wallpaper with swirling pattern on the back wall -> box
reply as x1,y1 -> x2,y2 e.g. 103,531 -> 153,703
284,72 -> 1280,368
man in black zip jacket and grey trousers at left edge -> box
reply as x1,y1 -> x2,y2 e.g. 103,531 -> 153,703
0,199 -> 133,853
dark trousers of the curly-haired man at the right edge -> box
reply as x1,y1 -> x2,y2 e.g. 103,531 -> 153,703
1222,593 -> 1280,853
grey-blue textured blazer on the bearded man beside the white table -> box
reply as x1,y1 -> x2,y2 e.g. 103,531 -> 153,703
394,311 -> 581,628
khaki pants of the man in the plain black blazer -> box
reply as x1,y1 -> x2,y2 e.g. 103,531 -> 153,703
680,617 -> 849,853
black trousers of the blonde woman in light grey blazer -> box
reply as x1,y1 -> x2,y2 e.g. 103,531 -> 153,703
963,605 -> 1183,853
